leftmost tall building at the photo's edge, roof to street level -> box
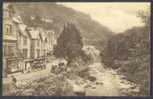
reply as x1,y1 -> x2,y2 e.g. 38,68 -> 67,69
3,4 -> 22,76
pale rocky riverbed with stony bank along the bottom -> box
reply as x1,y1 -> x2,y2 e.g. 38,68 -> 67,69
3,63 -> 139,96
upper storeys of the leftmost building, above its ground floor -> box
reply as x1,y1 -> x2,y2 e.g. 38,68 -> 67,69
3,5 -> 17,57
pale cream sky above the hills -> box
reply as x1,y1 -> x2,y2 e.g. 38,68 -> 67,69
59,2 -> 150,33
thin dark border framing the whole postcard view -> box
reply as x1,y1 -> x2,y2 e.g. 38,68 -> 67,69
0,0 -> 153,99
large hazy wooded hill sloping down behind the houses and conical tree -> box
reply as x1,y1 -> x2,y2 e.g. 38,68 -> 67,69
11,2 -> 113,45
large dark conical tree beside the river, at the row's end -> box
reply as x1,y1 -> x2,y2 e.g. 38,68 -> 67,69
54,23 -> 83,61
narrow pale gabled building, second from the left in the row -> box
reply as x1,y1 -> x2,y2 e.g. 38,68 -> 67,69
13,16 -> 34,72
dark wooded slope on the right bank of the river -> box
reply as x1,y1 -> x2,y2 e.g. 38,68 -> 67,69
101,12 -> 150,95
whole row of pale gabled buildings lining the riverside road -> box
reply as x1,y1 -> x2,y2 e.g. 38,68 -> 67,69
3,5 -> 56,75
